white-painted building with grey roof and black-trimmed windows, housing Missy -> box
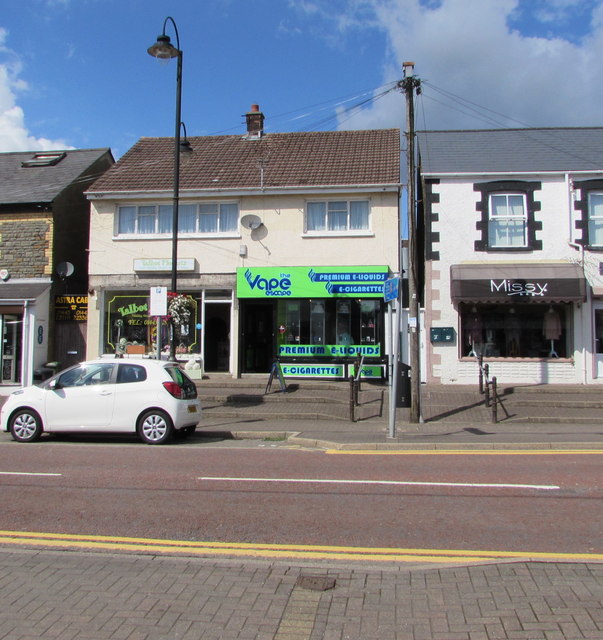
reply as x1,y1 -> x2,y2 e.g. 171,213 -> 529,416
419,129 -> 603,384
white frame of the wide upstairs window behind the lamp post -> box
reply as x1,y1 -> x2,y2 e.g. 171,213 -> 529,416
114,200 -> 241,240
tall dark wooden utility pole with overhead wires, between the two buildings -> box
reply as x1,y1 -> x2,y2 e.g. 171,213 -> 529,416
398,62 -> 422,423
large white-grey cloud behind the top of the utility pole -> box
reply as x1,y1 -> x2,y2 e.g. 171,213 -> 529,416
315,0 -> 603,129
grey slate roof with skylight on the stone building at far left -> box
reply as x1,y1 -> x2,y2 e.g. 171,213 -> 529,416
0,148 -> 110,204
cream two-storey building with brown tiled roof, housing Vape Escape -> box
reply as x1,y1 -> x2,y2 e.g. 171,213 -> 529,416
87,125 -> 400,378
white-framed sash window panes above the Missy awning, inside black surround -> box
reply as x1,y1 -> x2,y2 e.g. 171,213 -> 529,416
488,193 -> 528,248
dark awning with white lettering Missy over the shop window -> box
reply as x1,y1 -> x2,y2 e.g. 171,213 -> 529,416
450,263 -> 586,303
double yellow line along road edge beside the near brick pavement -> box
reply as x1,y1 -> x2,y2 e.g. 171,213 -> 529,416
0,531 -> 603,563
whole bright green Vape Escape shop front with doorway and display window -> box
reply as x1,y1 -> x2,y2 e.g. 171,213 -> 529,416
237,266 -> 389,379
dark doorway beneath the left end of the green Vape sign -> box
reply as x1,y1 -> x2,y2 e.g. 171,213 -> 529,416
243,302 -> 274,373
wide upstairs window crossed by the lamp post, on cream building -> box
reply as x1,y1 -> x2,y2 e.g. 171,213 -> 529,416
117,202 -> 239,236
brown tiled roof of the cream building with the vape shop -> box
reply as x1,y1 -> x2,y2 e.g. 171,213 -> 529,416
88,129 -> 400,194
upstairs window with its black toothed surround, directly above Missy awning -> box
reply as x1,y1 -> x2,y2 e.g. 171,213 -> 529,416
473,181 -> 542,251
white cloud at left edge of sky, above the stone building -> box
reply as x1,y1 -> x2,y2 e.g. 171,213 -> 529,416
0,28 -> 72,152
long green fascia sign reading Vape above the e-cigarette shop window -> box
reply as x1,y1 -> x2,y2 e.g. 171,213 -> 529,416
237,266 -> 389,298
